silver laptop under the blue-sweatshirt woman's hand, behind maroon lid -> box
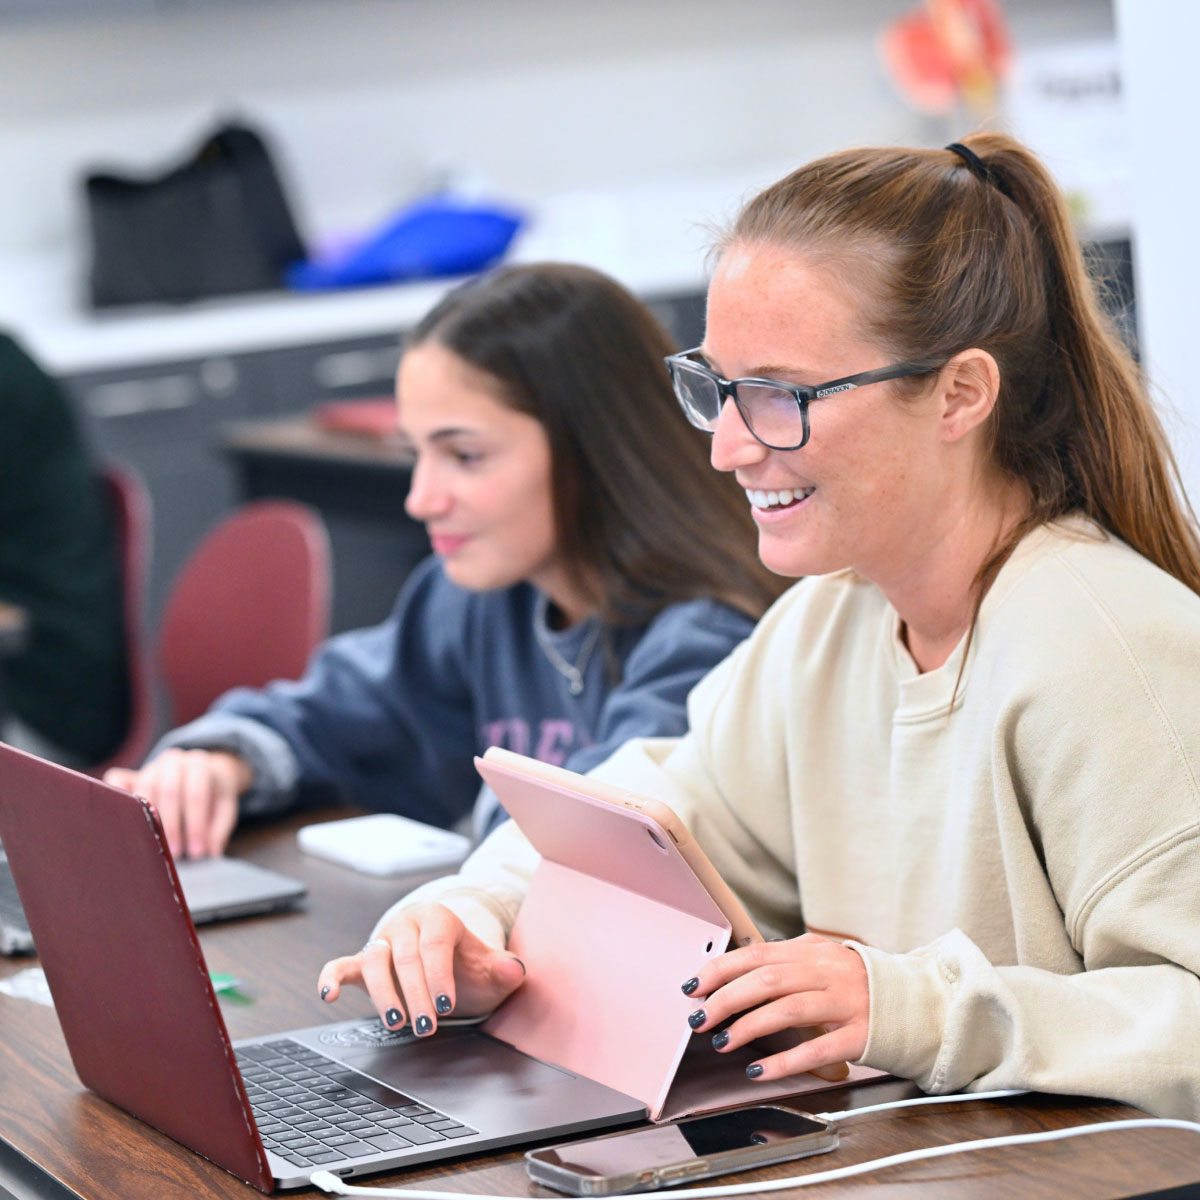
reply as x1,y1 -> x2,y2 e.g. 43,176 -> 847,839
0,846 -> 308,954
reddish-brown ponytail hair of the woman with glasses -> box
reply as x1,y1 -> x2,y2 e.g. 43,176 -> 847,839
718,133 -> 1200,600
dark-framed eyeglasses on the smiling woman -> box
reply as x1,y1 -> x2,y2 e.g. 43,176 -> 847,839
664,347 -> 938,450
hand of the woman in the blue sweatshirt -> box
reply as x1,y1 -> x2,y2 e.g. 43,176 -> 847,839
104,750 -> 253,858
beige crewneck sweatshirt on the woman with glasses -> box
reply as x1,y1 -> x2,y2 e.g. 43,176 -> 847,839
386,518 -> 1200,1120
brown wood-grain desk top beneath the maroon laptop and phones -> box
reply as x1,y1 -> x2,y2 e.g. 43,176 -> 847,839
0,814 -> 1200,1200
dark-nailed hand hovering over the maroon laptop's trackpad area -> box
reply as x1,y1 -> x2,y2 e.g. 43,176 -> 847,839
317,904 -> 526,1037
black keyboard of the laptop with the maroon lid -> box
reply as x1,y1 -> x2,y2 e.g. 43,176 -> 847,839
238,1038 -> 478,1166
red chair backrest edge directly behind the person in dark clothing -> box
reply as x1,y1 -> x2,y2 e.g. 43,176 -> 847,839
91,463 -> 155,775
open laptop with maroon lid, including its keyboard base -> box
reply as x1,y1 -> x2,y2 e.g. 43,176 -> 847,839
0,745 -> 647,1190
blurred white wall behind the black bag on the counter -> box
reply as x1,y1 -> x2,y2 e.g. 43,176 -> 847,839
0,0 -> 1112,260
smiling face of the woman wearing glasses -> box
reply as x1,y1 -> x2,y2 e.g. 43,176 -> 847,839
703,245 -> 947,587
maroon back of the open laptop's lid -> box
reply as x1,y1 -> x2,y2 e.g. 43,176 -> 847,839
0,745 -> 271,1192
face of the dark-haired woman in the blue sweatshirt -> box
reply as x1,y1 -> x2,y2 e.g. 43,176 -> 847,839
396,342 -> 558,595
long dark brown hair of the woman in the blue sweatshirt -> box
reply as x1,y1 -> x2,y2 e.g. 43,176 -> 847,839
408,263 -> 788,624
